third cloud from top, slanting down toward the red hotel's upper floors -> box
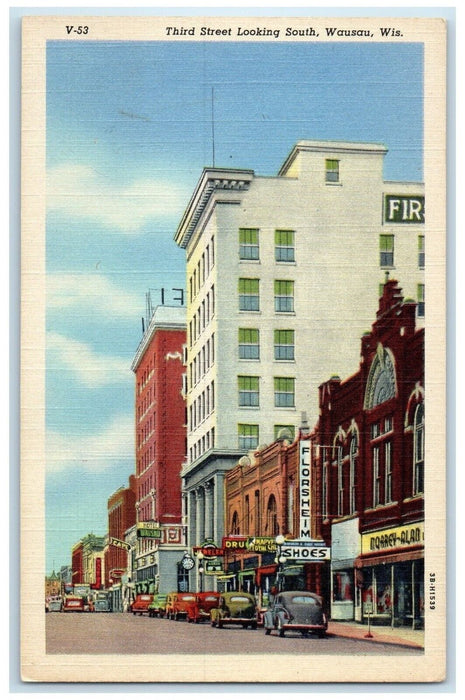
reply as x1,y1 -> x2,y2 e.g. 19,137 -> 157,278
47,333 -> 130,389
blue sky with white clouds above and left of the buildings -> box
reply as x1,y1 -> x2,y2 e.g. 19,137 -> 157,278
46,41 -> 423,573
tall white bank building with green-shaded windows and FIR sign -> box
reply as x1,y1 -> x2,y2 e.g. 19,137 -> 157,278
175,141 -> 424,546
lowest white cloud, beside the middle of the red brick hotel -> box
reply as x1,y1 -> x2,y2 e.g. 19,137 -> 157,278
46,415 -> 135,473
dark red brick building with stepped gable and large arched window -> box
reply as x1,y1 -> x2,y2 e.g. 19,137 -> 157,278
312,280 -> 425,626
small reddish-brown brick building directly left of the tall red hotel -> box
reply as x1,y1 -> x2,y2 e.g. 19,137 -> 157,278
105,474 -> 136,588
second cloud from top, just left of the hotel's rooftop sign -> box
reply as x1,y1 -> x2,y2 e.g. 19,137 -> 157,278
47,273 -> 144,318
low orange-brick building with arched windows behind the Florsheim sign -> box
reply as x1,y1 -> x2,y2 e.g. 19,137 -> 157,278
222,436 -> 329,597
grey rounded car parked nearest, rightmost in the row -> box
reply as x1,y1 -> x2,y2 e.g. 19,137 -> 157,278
263,591 -> 328,637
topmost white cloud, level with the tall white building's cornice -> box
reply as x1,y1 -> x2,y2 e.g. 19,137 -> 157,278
47,163 -> 186,233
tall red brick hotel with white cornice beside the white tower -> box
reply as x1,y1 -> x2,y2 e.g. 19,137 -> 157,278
132,306 -> 186,593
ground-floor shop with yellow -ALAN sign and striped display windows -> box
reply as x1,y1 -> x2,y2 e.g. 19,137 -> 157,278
355,522 -> 425,629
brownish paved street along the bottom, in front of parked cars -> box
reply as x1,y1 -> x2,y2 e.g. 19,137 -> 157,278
45,613 -> 423,656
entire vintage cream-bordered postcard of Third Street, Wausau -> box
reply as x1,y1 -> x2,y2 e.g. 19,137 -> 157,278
21,12 -> 447,684
